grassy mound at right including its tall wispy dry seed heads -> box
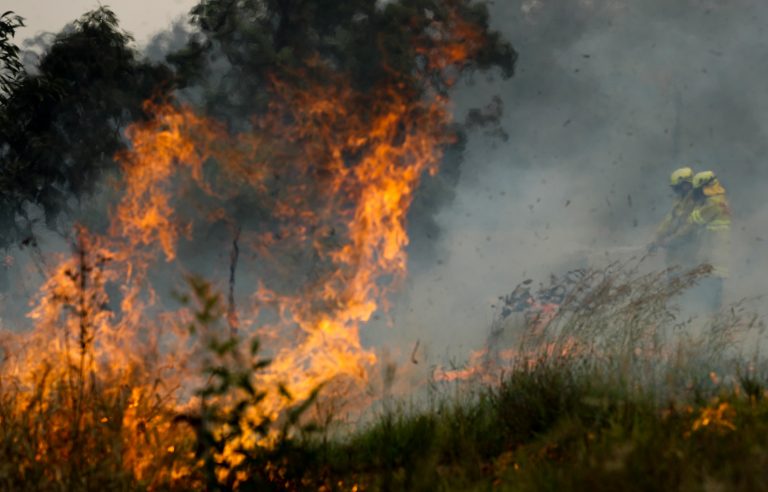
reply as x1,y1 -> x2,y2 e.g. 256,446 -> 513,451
312,265 -> 768,491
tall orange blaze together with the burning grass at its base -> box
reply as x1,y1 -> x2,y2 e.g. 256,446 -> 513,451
0,4 -> 496,490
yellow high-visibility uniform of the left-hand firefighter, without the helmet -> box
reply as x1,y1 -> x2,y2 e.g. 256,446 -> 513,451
654,191 -> 698,268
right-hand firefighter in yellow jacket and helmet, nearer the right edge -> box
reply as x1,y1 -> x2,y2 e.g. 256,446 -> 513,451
673,171 -> 731,311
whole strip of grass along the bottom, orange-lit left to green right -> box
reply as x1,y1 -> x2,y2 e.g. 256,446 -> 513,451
0,266 -> 768,492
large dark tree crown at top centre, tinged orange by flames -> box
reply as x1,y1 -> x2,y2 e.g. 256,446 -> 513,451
167,0 -> 517,258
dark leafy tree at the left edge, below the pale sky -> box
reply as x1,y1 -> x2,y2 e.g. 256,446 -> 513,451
0,7 -> 170,247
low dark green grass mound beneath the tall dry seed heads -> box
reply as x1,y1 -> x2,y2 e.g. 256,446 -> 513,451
296,360 -> 768,492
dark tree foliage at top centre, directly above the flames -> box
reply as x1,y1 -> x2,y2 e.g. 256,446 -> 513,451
179,0 -> 516,116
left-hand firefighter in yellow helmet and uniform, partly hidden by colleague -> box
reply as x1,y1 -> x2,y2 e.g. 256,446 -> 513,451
648,167 -> 697,275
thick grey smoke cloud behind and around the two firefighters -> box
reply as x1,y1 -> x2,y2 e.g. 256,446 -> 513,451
376,0 -> 768,361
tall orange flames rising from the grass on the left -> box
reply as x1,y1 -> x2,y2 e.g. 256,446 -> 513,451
3,1 -> 492,479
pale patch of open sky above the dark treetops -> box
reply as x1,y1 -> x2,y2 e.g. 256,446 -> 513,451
9,0 -> 197,46
